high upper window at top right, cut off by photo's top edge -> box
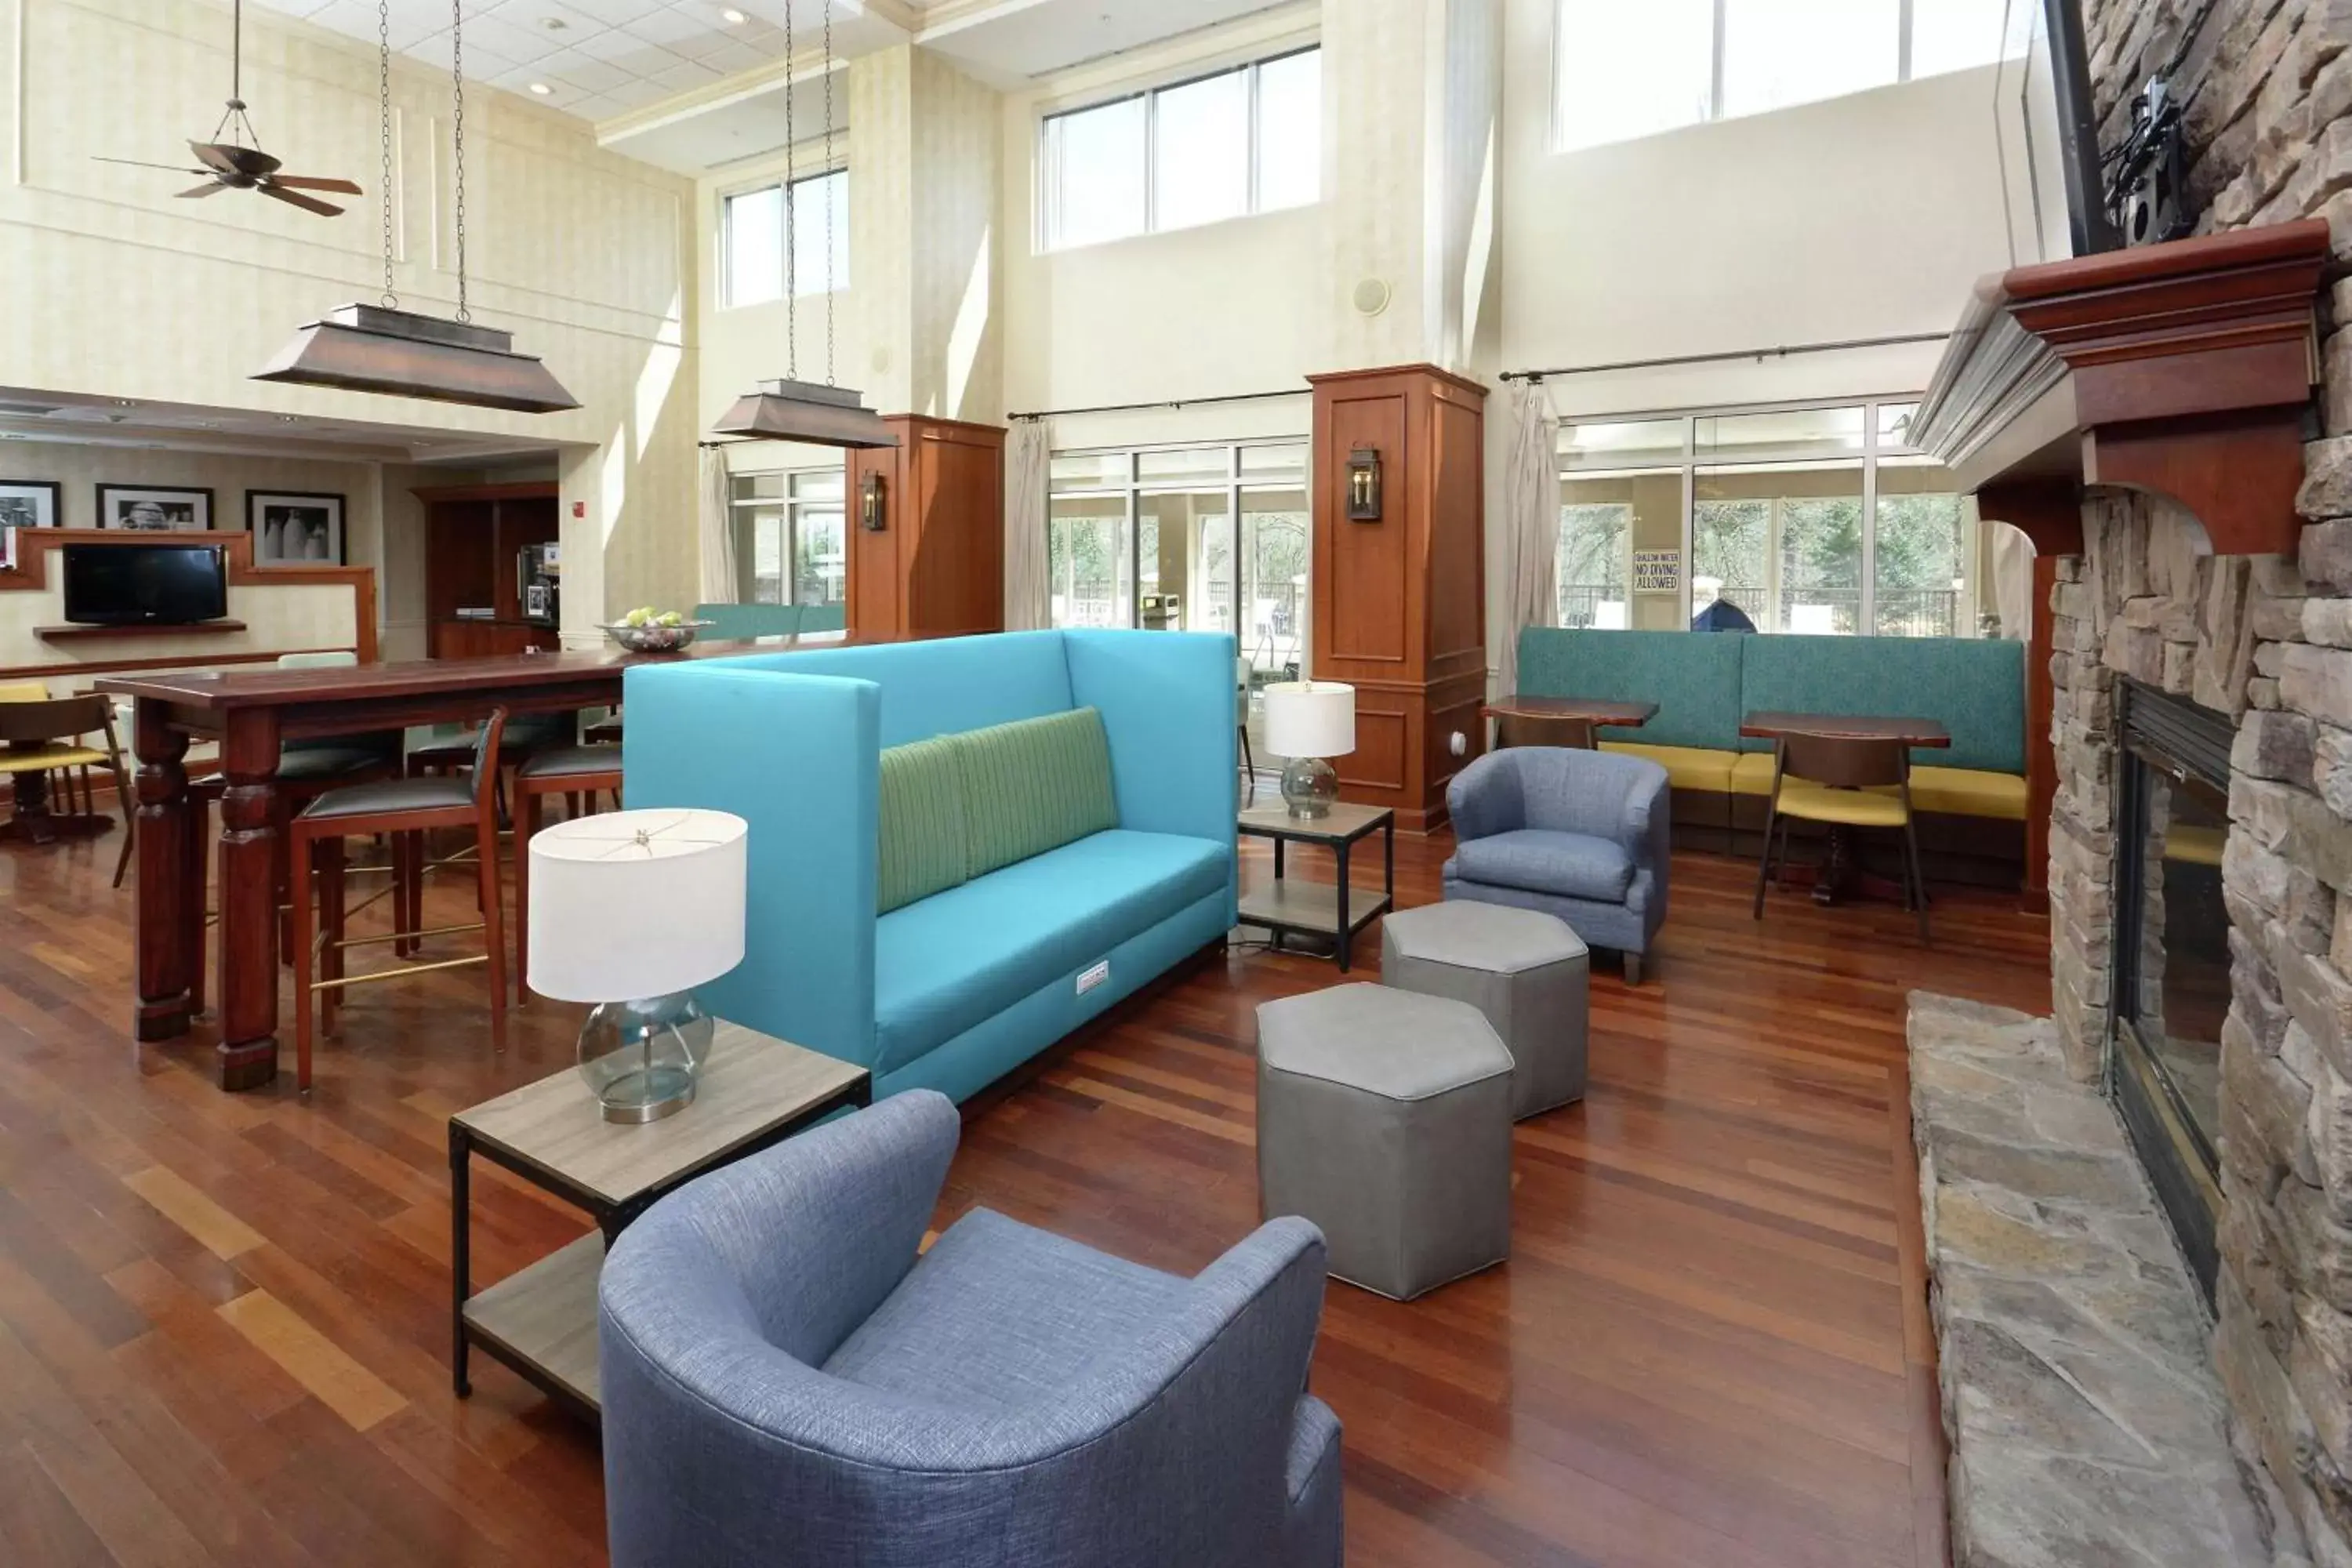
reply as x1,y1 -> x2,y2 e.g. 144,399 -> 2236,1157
1552,0 -> 2042,151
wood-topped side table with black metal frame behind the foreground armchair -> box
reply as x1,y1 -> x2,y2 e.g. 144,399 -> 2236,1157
449,1022 -> 873,1420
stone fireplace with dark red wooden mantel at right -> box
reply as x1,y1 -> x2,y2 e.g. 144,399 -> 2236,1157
1915,0 -> 2352,1568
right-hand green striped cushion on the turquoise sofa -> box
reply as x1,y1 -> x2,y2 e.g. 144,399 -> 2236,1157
953,708 -> 1120,877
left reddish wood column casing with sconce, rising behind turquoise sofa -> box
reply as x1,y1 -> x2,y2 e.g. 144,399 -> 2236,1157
844,414 -> 1004,637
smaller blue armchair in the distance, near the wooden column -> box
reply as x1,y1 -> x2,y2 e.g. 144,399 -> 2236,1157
1444,746 -> 1672,985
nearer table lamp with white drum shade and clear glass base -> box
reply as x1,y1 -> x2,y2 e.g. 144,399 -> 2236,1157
527,808 -> 750,1121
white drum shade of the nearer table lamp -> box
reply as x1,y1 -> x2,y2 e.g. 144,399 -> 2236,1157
529,808 -> 750,1001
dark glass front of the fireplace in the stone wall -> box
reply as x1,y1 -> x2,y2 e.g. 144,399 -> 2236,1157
2110,682 -> 2232,1293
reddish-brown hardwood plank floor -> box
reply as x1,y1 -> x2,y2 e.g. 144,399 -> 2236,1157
0,808 -> 2049,1568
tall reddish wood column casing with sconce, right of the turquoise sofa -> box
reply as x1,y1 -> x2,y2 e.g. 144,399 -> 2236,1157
1308,365 -> 1486,832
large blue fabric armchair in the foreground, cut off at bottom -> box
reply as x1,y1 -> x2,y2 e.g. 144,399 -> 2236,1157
600,1088 -> 1341,1568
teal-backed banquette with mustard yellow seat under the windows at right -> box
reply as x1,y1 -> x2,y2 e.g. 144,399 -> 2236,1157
1519,626 -> 2027,881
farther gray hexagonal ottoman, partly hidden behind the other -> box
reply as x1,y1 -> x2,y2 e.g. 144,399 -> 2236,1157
1381,900 -> 1592,1121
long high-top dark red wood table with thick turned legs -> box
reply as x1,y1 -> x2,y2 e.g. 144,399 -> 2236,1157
96,633 -> 896,1088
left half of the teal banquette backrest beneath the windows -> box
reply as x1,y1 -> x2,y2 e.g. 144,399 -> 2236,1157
1519,626 -> 1750,750
